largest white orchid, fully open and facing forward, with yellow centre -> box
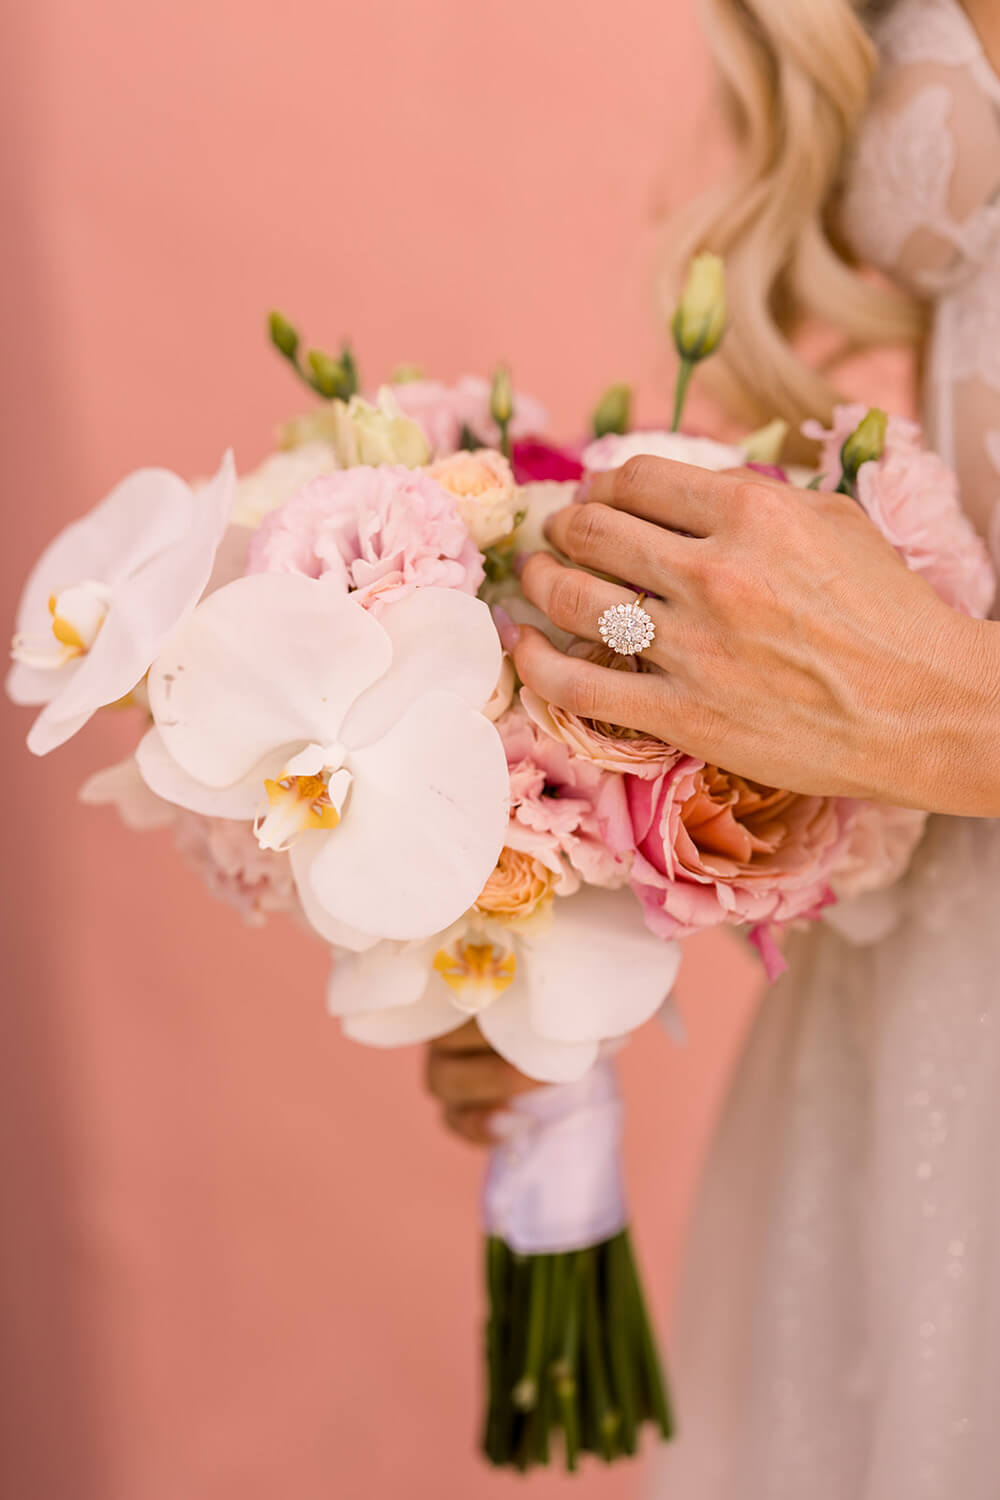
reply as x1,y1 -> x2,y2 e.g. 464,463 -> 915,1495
138,573 -> 510,950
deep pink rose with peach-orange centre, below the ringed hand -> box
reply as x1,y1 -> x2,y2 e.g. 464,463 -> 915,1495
625,756 -> 852,938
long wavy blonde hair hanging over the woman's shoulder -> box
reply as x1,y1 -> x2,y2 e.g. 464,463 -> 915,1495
663,0 -> 927,434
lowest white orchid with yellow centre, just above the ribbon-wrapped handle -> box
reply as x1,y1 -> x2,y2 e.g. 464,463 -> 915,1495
327,887 -> 681,1083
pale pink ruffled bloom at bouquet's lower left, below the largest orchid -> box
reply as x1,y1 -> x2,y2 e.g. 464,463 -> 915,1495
174,812 -> 300,927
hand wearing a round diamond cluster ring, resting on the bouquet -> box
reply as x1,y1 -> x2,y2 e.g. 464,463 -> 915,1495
508,458 -> 1000,816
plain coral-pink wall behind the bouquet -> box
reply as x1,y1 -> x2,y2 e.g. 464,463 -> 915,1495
0,0 -> 753,1500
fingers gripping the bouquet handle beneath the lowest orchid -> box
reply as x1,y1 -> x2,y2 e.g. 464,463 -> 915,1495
426,1022 -> 538,1146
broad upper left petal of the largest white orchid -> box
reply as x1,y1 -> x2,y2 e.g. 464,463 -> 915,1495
150,573 -> 391,786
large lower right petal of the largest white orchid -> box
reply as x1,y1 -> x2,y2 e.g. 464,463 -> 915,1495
305,687 -> 510,939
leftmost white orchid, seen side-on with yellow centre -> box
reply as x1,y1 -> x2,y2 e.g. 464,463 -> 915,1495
7,453 -> 235,755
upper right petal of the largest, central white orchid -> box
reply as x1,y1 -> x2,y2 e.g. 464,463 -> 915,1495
340,588 -> 504,747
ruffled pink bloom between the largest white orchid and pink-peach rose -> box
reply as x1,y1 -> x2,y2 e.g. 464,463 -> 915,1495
496,707 -> 631,896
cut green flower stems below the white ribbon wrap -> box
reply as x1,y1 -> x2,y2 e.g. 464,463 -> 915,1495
483,1230 -> 672,1472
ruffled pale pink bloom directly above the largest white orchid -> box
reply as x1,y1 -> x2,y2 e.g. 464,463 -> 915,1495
247,467 -> 483,605
